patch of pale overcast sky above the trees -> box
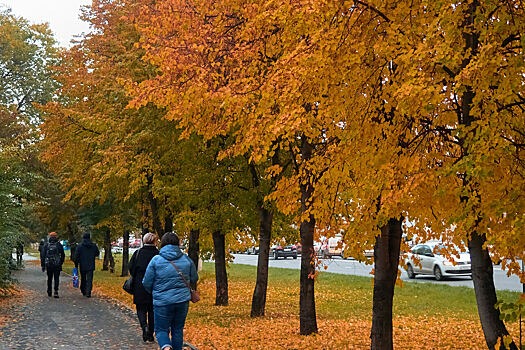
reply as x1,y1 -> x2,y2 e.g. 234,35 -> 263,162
0,0 -> 91,47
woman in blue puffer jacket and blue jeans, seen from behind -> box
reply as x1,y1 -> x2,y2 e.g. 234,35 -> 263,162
142,232 -> 199,350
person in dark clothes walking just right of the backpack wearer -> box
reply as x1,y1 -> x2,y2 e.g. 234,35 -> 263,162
73,233 -> 100,298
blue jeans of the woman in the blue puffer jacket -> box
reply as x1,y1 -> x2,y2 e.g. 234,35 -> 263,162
153,301 -> 190,350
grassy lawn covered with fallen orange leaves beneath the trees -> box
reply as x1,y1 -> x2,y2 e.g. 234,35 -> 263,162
66,263 -> 519,350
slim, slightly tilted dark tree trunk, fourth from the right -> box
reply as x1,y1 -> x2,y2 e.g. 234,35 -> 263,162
250,204 -> 273,317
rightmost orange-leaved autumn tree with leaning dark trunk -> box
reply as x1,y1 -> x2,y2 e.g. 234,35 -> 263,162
348,1 -> 523,348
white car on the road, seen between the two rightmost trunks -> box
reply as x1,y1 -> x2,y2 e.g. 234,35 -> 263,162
405,241 -> 472,281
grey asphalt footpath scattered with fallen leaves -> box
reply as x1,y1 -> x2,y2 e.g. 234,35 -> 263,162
0,261 -> 158,350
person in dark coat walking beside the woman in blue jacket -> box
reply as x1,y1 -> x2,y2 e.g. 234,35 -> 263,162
129,233 -> 159,342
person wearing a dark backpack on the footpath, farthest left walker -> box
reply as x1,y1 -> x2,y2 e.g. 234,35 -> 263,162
41,232 -> 66,298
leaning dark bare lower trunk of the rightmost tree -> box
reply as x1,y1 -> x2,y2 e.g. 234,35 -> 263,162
468,232 -> 518,350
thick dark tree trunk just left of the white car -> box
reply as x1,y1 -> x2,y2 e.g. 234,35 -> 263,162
370,219 -> 402,350
